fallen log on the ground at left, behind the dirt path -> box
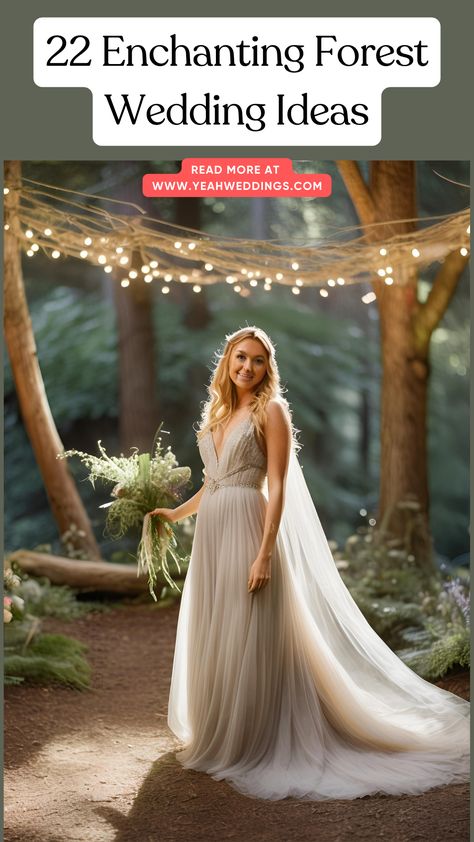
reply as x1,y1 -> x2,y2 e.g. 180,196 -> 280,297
10,550 -> 148,594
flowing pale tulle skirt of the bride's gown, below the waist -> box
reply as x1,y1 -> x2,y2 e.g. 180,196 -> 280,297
168,487 -> 469,800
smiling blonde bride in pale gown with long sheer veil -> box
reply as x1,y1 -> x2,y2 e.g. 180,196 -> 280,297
153,327 -> 469,800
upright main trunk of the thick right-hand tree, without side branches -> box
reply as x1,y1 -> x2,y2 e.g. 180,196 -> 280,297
370,161 -> 431,557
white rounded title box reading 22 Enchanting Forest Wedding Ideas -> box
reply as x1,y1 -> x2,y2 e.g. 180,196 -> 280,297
34,17 -> 440,146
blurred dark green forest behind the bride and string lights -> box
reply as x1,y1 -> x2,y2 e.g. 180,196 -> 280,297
5,161 -> 469,566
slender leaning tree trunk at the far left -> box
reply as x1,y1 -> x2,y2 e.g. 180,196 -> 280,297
4,161 -> 100,559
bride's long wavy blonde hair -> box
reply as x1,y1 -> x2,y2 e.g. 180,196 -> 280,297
197,325 -> 295,446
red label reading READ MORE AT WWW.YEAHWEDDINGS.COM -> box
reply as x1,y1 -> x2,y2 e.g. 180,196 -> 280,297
143,158 -> 332,199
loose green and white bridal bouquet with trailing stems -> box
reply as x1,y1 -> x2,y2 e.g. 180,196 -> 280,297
59,437 -> 191,601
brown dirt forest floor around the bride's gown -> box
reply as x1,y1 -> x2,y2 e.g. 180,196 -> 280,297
5,604 -> 469,842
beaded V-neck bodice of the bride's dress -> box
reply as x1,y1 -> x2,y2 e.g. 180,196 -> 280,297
198,417 -> 267,494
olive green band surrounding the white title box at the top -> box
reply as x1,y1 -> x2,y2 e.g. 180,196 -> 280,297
1,0 -> 474,160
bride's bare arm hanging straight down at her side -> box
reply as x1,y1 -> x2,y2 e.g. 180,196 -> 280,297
248,401 -> 291,592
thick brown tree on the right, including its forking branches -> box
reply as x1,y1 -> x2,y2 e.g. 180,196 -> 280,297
337,161 -> 468,560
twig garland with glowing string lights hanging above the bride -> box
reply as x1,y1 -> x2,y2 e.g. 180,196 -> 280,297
5,174 -> 470,297
